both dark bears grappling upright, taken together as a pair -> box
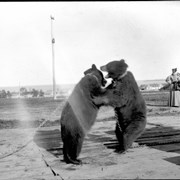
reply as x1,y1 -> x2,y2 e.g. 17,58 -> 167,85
61,60 -> 146,164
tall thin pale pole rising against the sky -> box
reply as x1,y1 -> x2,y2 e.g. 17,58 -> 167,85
51,16 -> 56,99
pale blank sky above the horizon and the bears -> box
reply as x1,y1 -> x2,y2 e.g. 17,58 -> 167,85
0,1 -> 180,87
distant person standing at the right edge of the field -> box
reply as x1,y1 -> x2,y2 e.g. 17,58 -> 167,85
166,68 -> 180,107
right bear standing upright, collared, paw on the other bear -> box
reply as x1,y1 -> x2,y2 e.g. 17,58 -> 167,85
94,59 -> 146,153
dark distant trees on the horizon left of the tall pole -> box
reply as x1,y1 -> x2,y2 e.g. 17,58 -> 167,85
0,87 -> 44,98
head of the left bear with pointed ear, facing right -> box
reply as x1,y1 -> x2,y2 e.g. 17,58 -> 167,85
84,64 -> 107,86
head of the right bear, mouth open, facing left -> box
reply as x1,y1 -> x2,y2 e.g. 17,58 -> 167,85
100,59 -> 128,80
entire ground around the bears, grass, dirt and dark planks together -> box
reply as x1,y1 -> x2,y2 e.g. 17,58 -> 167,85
0,91 -> 180,180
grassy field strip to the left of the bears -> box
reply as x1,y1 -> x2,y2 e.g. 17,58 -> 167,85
0,98 -> 65,129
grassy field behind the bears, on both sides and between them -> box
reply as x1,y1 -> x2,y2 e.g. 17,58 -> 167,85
0,91 -> 180,129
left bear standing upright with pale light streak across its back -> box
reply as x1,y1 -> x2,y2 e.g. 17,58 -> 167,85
60,64 -> 107,164
